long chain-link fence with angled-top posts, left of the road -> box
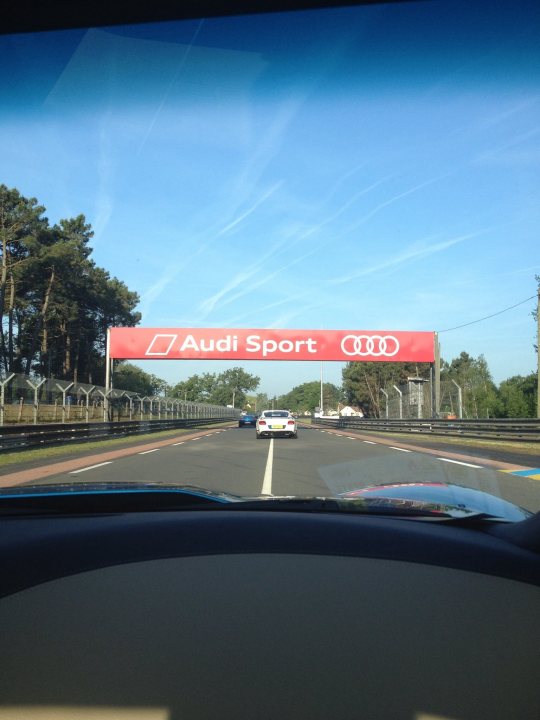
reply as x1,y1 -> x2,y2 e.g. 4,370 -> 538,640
0,373 -> 237,425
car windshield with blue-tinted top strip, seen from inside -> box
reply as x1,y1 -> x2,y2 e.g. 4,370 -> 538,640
0,0 -> 540,512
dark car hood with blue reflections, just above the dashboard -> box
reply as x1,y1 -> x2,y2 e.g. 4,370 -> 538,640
0,482 -> 532,522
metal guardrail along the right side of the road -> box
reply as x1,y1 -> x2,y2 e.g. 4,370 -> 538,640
312,417 -> 540,442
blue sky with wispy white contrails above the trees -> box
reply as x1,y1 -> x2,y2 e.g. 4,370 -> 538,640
0,2 -> 540,395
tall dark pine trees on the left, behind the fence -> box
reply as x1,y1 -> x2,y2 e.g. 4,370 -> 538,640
0,185 -> 141,385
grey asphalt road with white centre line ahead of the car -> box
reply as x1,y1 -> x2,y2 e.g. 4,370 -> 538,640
26,427 -> 540,512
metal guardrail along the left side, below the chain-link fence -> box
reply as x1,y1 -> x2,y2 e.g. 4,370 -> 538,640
0,417 -> 233,454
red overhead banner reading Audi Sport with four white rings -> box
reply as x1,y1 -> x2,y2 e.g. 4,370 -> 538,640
109,328 -> 435,362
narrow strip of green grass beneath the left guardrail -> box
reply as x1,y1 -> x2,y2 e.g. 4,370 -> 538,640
0,423 -> 229,468
